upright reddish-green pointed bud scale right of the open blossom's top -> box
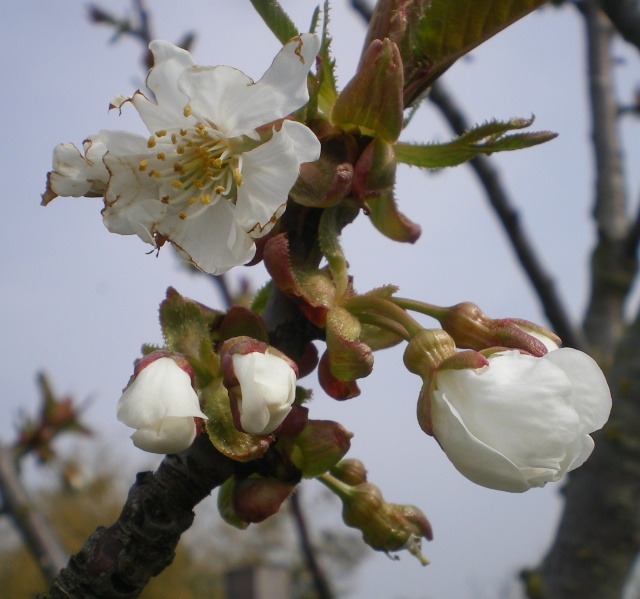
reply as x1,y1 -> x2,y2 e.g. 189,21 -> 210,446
331,39 -> 403,142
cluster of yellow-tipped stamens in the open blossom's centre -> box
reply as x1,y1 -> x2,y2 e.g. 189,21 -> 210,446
138,117 -> 242,220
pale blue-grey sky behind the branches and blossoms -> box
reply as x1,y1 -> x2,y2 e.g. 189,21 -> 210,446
0,0 -> 640,599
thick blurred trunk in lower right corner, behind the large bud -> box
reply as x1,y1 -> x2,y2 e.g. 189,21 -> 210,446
525,308 -> 640,599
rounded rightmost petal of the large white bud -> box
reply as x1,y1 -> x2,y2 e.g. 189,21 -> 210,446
542,347 -> 611,433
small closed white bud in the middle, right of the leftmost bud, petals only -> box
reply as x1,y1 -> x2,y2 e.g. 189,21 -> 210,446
232,352 -> 296,435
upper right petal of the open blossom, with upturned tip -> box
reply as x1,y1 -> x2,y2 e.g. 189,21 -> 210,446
180,34 -> 320,137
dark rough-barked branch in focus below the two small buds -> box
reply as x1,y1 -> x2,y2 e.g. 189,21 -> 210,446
39,434 -> 237,599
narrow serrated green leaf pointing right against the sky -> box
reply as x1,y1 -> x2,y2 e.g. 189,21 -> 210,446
395,118 -> 557,169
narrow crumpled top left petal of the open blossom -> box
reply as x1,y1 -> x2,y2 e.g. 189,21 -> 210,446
131,40 -> 195,133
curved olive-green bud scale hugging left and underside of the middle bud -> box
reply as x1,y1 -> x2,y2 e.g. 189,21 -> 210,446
199,378 -> 271,462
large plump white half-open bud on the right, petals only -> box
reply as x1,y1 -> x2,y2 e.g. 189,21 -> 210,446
431,346 -> 611,492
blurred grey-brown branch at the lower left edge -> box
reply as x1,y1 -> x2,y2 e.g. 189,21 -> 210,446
0,446 -> 69,582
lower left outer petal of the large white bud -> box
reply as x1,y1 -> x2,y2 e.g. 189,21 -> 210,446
431,391 -> 531,493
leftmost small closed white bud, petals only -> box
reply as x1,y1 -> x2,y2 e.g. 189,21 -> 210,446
117,357 -> 207,453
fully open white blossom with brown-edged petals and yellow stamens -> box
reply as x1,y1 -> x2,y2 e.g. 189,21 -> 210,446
43,34 -> 320,274
